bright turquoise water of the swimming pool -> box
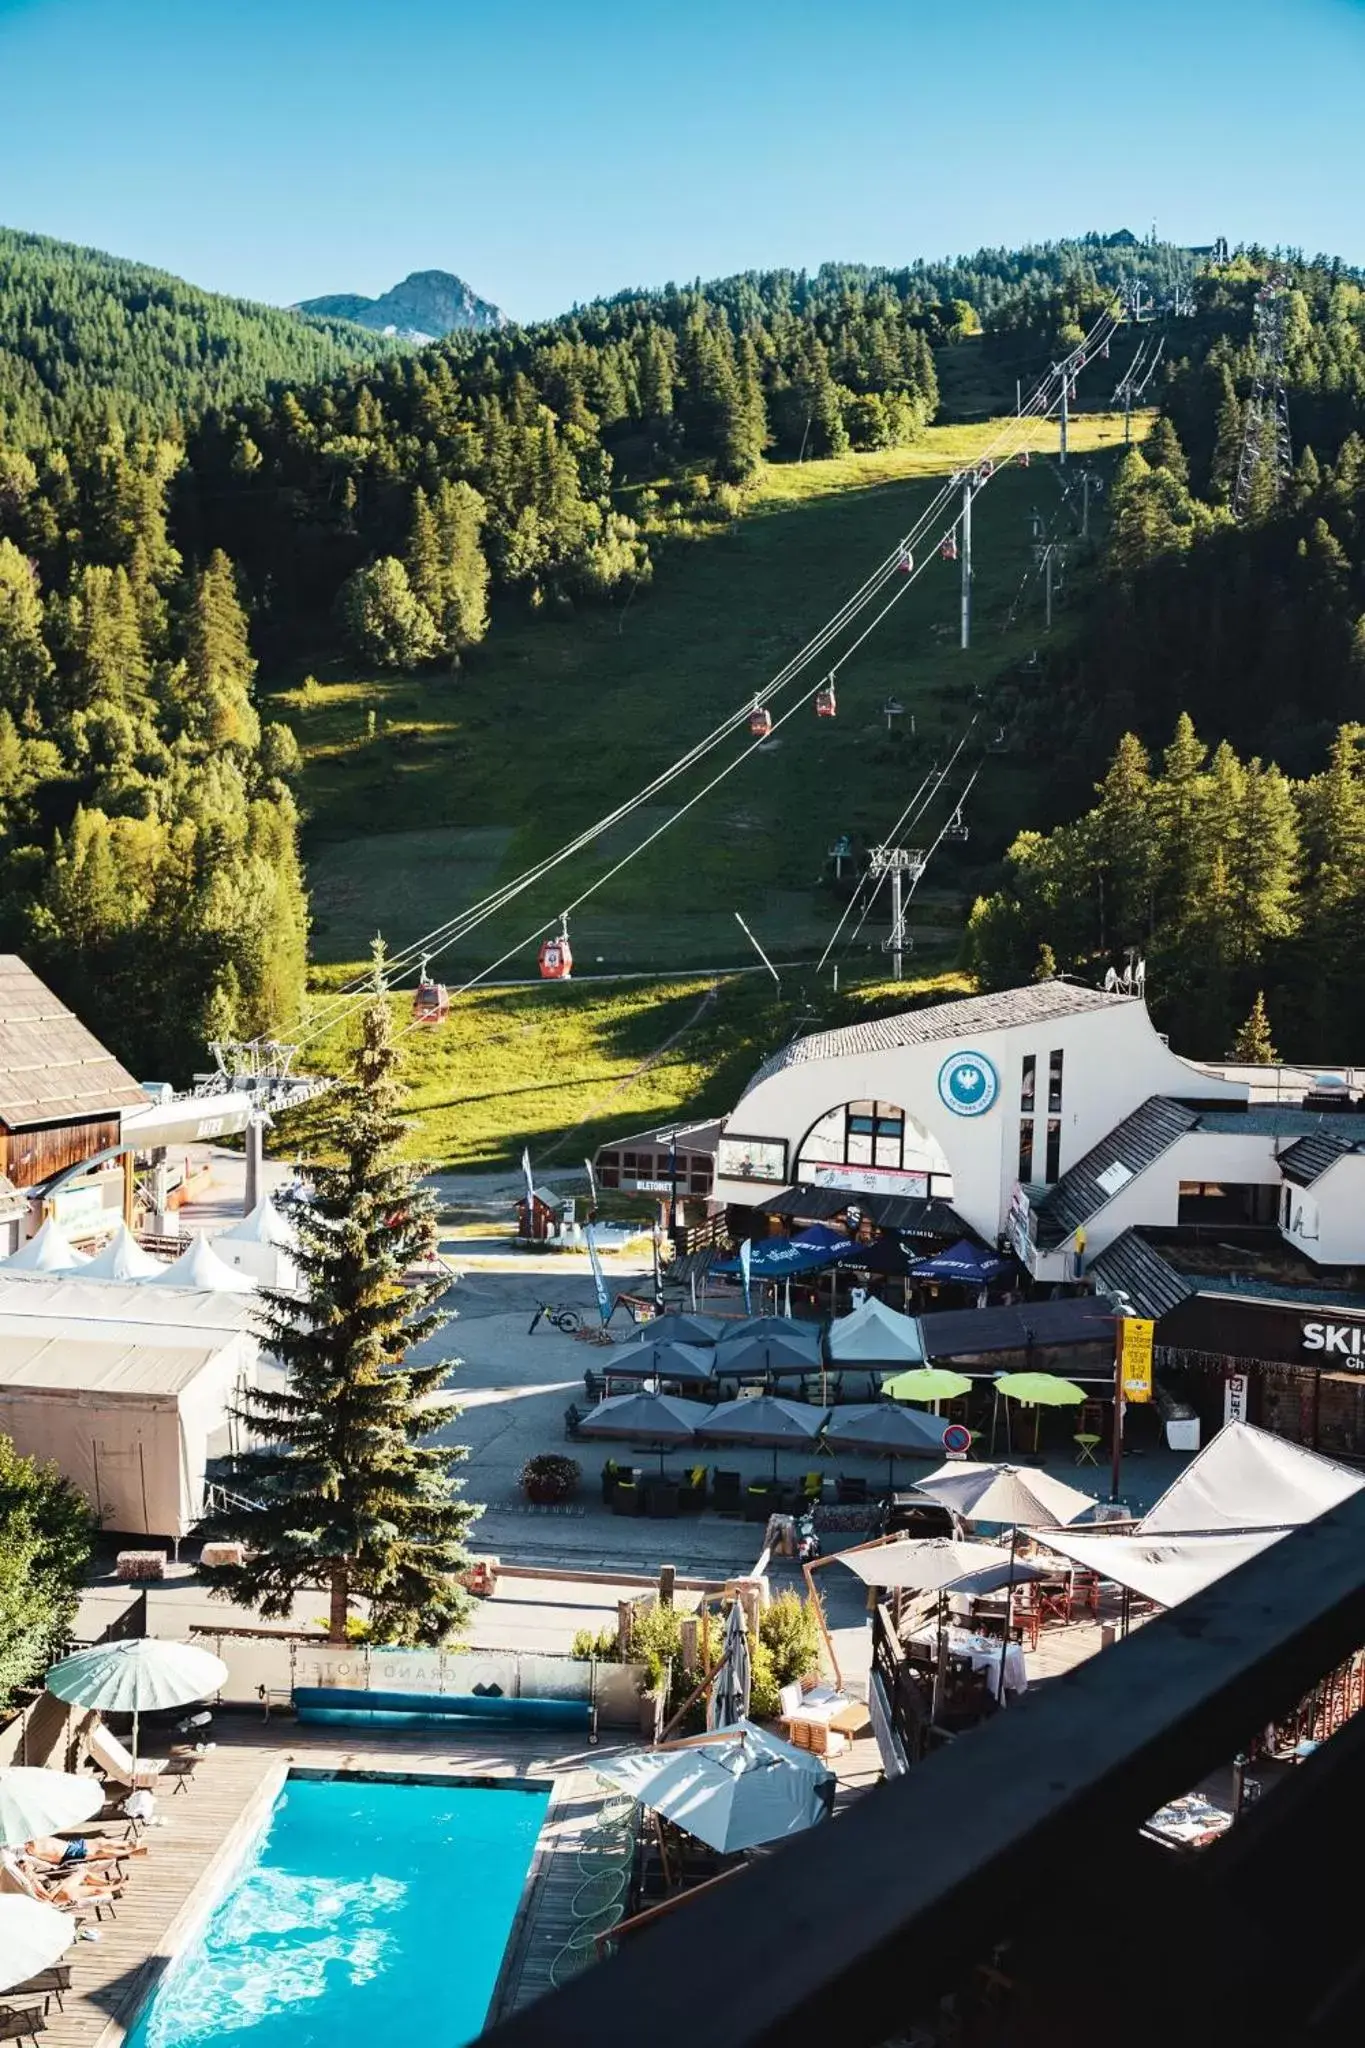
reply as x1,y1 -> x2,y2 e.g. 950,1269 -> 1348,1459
127,1778 -> 548,2048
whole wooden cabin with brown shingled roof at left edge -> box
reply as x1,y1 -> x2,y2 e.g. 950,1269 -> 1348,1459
0,952 -> 147,1188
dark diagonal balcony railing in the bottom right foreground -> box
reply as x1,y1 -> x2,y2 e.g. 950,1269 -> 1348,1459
489,1495 -> 1365,2048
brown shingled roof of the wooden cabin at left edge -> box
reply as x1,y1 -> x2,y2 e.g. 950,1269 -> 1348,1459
0,952 -> 147,1130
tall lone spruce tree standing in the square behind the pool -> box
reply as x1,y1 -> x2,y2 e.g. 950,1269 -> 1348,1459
202,975 -> 479,1645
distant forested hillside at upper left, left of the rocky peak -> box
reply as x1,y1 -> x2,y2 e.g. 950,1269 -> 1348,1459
0,227 -> 393,449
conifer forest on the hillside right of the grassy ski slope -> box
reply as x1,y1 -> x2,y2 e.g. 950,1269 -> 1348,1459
970,260 -> 1365,1059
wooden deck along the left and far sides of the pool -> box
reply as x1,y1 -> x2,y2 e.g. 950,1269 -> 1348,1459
13,1714 -> 596,2048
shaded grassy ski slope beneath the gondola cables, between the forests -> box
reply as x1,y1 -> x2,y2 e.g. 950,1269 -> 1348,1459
274,416 -> 1146,979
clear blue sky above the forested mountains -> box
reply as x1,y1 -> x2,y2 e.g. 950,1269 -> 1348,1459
0,0 -> 1365,319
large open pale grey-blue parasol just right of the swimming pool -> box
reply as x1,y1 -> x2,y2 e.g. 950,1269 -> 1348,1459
593,1720 -> 835,1855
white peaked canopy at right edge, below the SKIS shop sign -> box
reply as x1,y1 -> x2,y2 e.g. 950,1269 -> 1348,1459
1142,1421 -> 1365,1536
